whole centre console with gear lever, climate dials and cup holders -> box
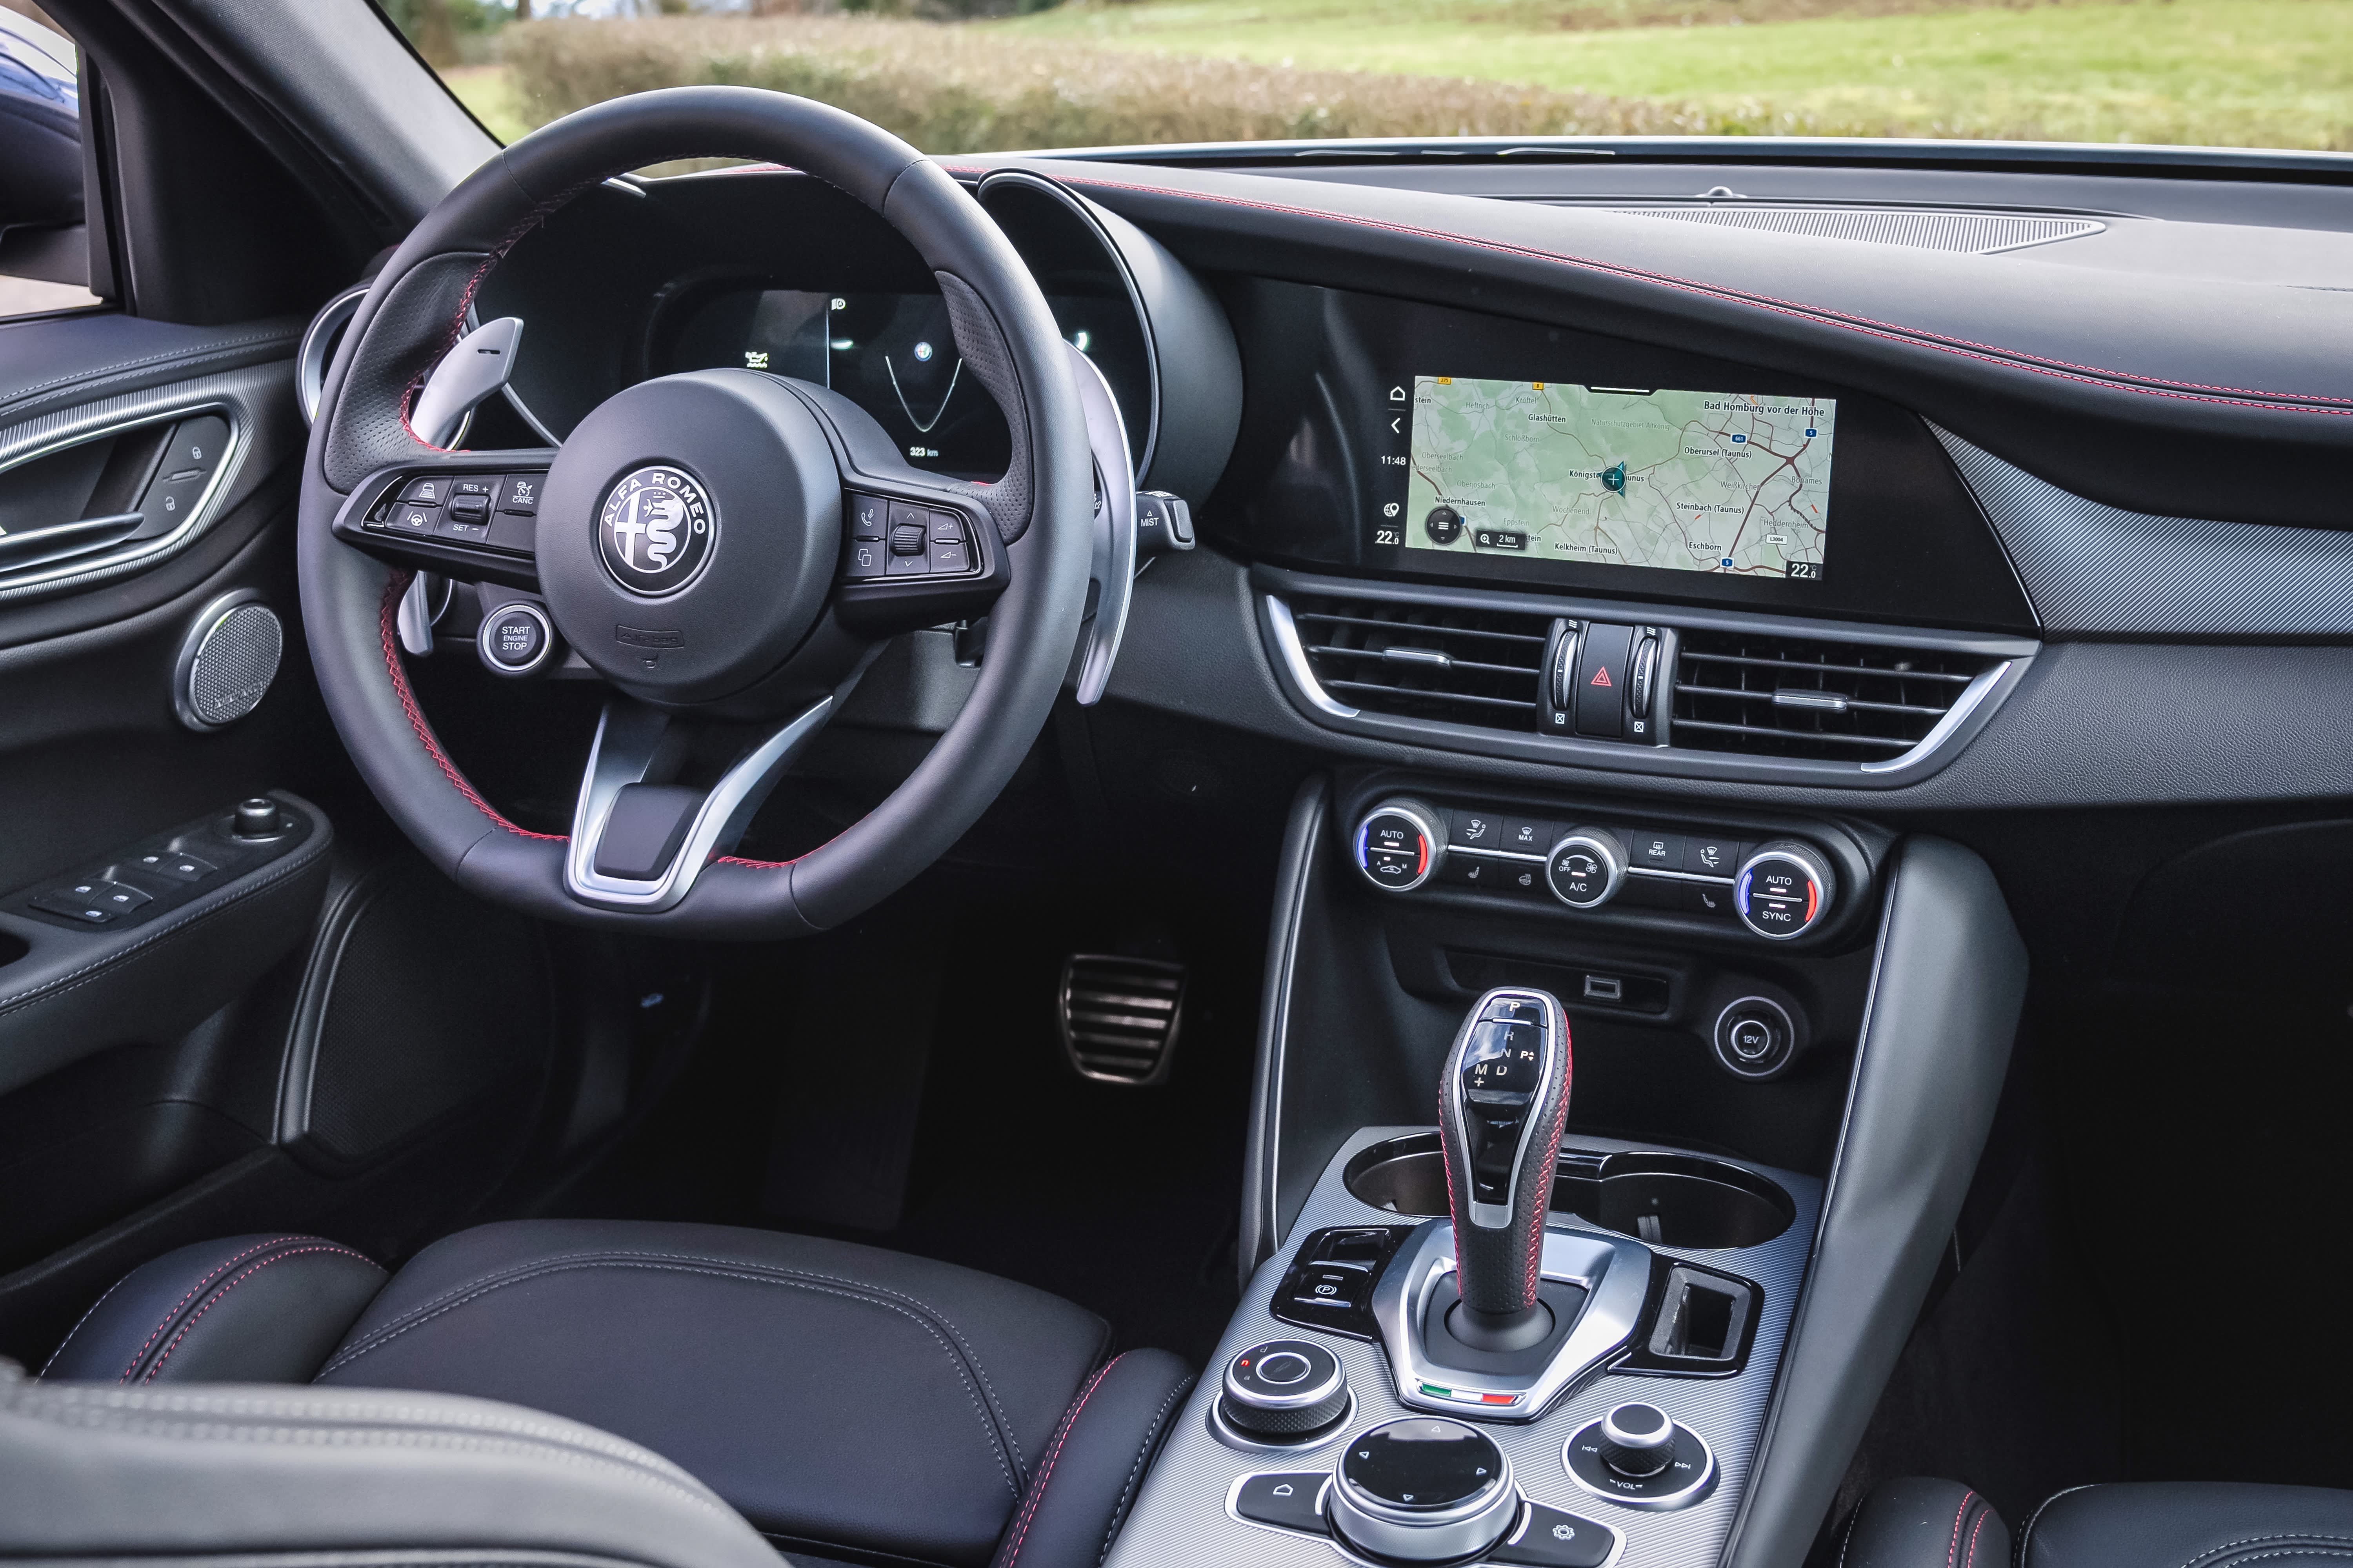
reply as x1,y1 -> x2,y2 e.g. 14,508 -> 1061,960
1106,770 -> 2024,1568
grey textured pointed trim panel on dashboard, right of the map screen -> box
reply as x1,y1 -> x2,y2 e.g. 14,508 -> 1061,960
1929,422 -> 2353,638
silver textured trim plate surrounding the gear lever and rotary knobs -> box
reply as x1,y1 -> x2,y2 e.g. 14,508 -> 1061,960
1104,1128 -> 1821,1568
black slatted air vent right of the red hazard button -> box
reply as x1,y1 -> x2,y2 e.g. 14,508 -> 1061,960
1671,631 -> 1993,763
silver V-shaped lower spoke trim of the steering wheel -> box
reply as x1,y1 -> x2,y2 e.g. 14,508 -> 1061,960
565,697 -> 833,911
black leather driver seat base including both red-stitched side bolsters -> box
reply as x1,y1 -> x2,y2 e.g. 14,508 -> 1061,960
42,1219 -> 1193,1568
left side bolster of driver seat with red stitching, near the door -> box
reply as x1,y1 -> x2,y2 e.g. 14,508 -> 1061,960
42,1236 -> 388,1384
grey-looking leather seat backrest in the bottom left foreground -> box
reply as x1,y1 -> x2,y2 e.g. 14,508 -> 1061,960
0,1361 -> 779,1568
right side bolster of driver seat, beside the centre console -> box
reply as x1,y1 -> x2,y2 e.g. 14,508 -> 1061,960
995,1352 -> 1193,1568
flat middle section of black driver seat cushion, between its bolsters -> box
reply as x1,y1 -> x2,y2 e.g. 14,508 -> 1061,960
318,1219 -> 1108,1566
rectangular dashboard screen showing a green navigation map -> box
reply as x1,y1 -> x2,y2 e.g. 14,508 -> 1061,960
1377,374 -> 1838,581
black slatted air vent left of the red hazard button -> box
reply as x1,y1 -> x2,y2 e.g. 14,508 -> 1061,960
1292,593 -> 1553,732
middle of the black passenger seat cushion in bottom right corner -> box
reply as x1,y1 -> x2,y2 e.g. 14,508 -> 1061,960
2019,1481 -> 2353,1568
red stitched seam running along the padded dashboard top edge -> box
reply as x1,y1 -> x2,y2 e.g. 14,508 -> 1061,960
1068,176 -> 2353,417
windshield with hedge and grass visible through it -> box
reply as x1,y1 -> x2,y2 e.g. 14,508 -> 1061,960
381,0 -> 2353,153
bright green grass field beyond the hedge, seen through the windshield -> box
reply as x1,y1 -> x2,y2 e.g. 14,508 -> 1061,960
986,0 -> 2353,148
